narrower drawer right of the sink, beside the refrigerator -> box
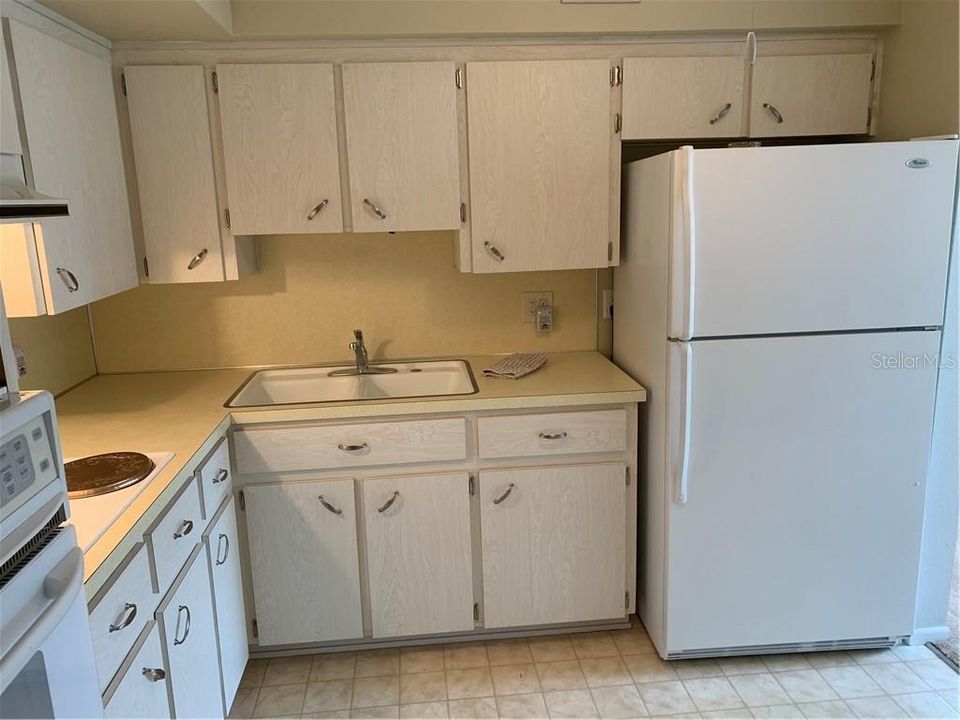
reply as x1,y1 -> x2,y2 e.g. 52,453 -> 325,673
477,408 -> 627,458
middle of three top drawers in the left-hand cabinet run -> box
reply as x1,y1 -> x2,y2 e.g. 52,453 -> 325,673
143,478 -> 201,595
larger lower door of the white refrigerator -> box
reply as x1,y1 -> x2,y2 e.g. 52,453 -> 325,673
666,331 -> 940,653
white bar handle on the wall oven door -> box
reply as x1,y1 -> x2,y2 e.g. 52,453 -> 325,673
0,547 -> 83,696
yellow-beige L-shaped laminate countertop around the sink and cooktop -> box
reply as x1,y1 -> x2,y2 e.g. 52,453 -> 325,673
57,352 -> 646,597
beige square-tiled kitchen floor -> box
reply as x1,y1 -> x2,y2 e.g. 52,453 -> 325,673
230,619 -> 960,718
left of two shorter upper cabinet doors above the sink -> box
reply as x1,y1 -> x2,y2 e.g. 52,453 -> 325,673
217,63 -> 343,235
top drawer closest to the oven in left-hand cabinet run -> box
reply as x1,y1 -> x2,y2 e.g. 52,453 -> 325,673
90,543 -> 160,693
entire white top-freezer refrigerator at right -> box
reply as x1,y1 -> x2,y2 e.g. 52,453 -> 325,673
614,141 -> 957,658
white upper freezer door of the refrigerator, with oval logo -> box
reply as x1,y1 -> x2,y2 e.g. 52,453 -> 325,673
669,141 -> 957,339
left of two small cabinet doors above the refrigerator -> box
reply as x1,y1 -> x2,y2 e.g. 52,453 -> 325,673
623,57 -> 747,140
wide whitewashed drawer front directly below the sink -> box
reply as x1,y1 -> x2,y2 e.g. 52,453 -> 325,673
234,418 -> 467,473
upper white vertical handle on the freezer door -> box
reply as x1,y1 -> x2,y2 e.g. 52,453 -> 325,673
671,145 -> 697,340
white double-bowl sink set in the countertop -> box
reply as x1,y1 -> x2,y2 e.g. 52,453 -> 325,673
226,360 -> 477,407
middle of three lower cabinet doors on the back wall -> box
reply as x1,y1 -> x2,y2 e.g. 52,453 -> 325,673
363,472 -> 473,637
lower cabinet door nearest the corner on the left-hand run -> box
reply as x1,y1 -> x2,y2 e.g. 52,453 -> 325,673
203,496 -> 249,713
